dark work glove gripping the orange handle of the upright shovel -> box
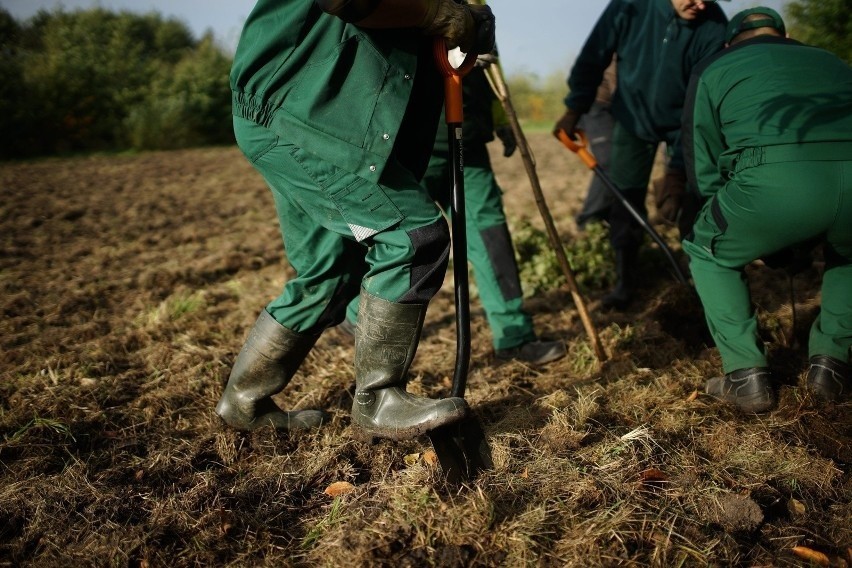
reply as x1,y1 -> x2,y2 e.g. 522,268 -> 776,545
421,0 -> 495,53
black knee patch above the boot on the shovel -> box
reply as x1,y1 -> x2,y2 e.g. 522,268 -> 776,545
398,218 -> 450,304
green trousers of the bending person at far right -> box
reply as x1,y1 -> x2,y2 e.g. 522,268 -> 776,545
683,149 -> 852,373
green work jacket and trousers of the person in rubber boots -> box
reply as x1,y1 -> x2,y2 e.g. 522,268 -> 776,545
231,0 -> 449,335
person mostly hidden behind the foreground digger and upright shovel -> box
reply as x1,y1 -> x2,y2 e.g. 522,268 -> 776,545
344,60 -> 566,365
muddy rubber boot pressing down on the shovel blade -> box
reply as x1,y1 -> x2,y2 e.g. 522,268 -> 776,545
352,290 -> 468,440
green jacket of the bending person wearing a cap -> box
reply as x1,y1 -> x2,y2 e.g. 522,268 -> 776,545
683,36 -> 852,197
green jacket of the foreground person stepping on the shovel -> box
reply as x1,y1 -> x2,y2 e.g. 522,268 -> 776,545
230,0 -> 443,182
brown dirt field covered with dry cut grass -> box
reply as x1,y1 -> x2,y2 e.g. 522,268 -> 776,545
0,134 -> 852,568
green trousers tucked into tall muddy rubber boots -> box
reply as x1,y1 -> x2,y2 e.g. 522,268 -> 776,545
234,117 -> 450,334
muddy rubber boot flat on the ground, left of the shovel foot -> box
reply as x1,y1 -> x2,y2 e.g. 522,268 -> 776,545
216,310 -> 326,430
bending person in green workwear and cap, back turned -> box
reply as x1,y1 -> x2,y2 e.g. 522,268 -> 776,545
683,7 -> 852,412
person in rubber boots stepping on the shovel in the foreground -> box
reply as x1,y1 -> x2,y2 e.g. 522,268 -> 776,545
216,0 -> 494,439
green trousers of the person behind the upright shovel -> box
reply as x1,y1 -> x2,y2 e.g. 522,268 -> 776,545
347,142 -> 536,349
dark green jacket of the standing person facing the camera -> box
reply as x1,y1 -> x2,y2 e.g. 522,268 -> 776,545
565,0 -> 728,167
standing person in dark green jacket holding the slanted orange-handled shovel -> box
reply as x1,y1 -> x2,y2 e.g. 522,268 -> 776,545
554,0 -> 728,310
